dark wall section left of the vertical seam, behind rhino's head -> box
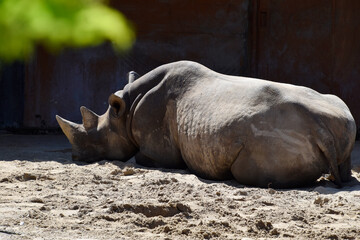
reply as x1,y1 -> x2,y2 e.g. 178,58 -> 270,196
24,0 -> 249,127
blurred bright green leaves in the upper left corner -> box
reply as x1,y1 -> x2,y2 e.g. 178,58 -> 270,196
0,0 -> 135,61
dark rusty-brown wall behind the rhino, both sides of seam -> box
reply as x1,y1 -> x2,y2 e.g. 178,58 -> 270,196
24,0 -> 360,131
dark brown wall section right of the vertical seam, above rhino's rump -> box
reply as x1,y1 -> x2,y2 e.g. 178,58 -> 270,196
252,0 -> 360,127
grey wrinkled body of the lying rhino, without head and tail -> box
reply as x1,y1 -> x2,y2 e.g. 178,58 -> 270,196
134,62 -> 355,186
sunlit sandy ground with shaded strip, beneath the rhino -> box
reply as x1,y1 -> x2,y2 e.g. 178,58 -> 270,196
0,132 -> 360,239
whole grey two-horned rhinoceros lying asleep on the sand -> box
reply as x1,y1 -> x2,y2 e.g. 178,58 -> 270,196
56,61 -> 356,188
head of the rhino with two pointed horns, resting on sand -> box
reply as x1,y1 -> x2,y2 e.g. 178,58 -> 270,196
56,79 -> 137,162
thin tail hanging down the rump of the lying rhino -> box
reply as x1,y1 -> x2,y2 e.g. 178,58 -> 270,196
317,128 -> 342,187
